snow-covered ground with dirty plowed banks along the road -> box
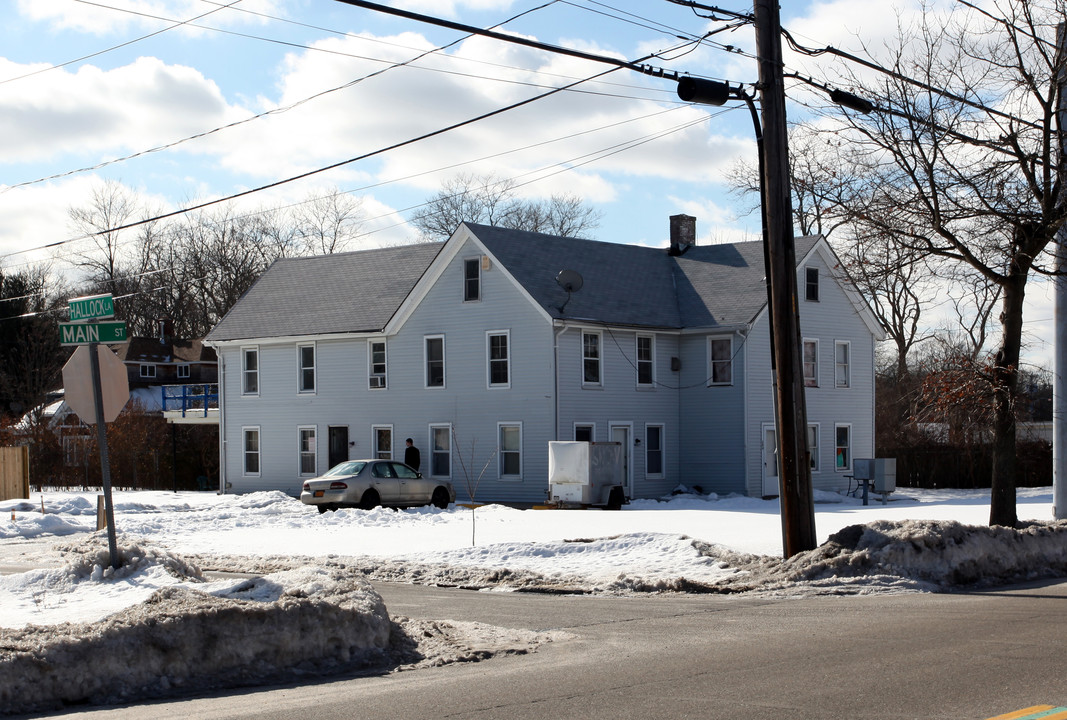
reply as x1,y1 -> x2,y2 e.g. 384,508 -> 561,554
0,489 -> 1067,713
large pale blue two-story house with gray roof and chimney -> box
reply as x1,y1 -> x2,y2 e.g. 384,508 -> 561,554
206,217 -> 881,502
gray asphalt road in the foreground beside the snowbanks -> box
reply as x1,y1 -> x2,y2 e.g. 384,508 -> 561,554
18,582 -> 1067,720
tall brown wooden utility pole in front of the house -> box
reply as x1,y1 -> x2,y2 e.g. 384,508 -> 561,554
754,0 -> 816,558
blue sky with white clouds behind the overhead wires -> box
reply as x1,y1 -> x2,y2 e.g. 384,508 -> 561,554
0,0 -> 1051,369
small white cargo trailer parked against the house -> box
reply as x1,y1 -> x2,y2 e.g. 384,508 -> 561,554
548,441 -> 625,508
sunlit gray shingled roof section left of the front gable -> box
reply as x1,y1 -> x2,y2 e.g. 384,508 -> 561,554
205,242 -> 444,342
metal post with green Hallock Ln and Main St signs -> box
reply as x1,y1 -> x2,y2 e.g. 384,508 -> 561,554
60,294 -> 126,570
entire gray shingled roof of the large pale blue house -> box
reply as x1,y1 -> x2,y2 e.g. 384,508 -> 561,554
206,223 -> 818,342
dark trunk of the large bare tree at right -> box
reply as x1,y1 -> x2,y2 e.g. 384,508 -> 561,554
989,269 -> 1026,527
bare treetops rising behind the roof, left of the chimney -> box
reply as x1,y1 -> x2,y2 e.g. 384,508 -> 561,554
411,175 -> 600,240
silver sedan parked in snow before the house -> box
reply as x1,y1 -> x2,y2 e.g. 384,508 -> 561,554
300,460 -> 456,512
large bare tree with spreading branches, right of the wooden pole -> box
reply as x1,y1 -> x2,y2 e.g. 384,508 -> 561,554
806,0 -> 1067,526
